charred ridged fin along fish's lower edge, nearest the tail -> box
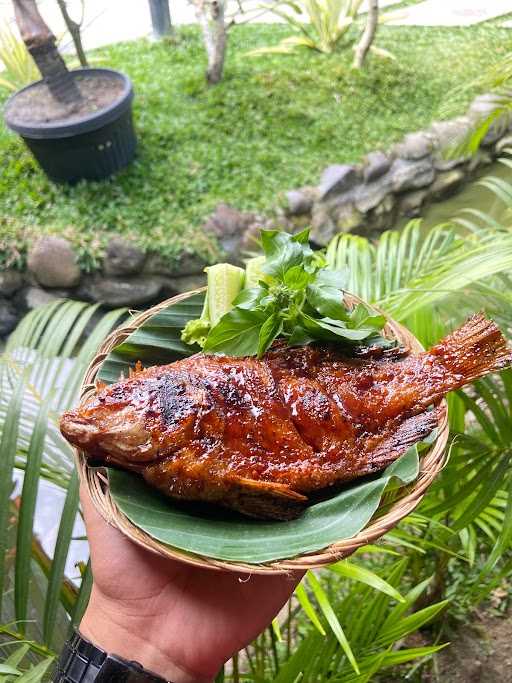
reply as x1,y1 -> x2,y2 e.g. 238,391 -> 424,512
364,409 -> 439,474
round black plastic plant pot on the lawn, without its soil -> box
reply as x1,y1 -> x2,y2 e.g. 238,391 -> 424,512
5,69 -> 137,183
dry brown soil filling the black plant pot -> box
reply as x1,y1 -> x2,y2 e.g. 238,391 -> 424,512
6,74 -> 124,125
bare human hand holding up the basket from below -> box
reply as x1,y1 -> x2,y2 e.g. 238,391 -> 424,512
80,490 -> 303,683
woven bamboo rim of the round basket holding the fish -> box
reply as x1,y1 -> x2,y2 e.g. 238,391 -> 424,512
75,290 -> 448,574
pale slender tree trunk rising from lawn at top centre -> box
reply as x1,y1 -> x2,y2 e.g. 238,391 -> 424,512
194,0 -> 227,84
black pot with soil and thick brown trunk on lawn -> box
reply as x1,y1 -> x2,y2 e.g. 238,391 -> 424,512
5,0 -> 136,183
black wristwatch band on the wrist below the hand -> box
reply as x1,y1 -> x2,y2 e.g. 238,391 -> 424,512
53,631 -> 171,683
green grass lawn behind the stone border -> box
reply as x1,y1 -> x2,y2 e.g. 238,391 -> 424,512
0,24 -> 512,267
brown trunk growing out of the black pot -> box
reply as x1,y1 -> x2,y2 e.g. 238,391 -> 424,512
13,0 -> 82,104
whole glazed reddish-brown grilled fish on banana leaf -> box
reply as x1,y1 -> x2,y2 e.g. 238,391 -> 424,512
60,315 -> 512,520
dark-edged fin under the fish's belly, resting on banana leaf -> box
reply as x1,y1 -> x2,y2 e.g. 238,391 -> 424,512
225,477 -> 308,521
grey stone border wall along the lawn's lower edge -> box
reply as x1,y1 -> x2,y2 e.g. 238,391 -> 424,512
0,95 -> 512,337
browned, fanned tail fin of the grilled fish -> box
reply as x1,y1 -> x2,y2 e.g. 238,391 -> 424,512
428,313 -> 512,392
